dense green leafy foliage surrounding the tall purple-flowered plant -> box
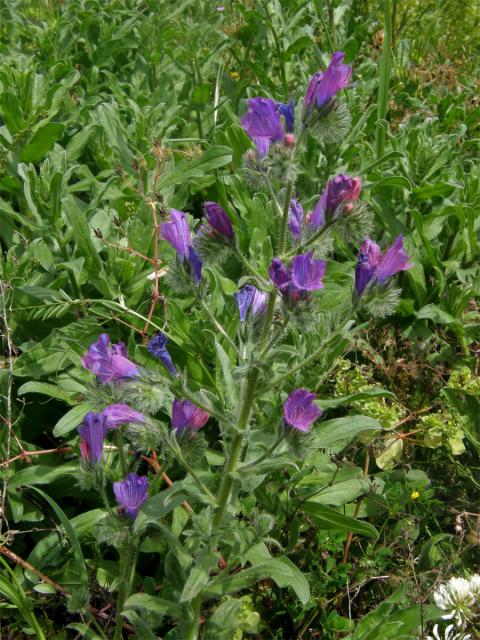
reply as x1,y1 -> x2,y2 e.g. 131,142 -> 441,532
0,0 -> 480,640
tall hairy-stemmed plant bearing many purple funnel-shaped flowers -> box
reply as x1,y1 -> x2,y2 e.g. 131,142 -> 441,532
43,52 -> 411,640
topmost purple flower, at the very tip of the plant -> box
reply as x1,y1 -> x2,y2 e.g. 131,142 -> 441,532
305,51 -> 352,113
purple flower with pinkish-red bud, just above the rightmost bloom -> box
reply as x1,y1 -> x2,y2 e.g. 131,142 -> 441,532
308,174 -> 362,230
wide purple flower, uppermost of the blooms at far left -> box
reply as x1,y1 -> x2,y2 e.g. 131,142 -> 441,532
82,333 -> 139,384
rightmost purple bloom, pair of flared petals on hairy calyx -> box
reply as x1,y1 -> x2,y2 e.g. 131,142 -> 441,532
355,236 -> 412,296
